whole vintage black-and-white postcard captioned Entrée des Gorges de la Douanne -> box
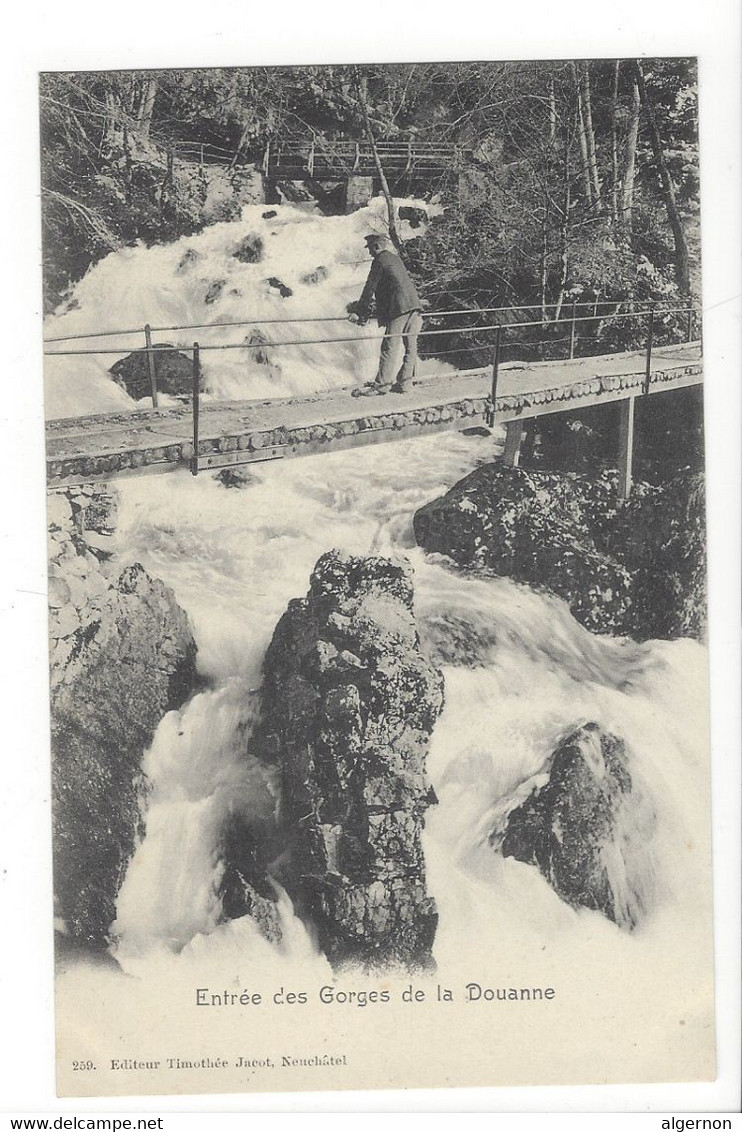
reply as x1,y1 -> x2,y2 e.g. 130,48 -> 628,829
40,58 -> 715,1097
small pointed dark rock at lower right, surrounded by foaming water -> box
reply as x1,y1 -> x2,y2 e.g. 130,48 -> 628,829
495,723 -> 654,931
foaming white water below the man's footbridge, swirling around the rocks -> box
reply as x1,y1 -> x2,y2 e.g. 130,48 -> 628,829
95,425 -> 710,971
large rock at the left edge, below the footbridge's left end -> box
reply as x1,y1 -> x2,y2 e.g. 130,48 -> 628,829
49,489 -> 196,947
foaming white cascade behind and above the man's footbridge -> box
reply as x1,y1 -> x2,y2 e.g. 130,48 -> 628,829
44,198 -> 451,418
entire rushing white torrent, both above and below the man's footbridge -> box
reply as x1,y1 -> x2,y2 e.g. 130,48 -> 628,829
48,205 -> 710,1005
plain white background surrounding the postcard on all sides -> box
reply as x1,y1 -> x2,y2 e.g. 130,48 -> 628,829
0,0 -> 742,1113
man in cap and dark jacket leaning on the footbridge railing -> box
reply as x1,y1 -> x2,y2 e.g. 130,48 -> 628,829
348,234 -> 423,395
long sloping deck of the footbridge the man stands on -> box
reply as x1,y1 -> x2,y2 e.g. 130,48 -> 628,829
46,343 -> 702,488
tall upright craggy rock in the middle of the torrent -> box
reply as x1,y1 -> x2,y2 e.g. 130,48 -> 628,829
251,551 -> 443,969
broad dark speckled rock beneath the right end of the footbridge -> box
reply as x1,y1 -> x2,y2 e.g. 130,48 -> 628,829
413,463 -> 706,640
